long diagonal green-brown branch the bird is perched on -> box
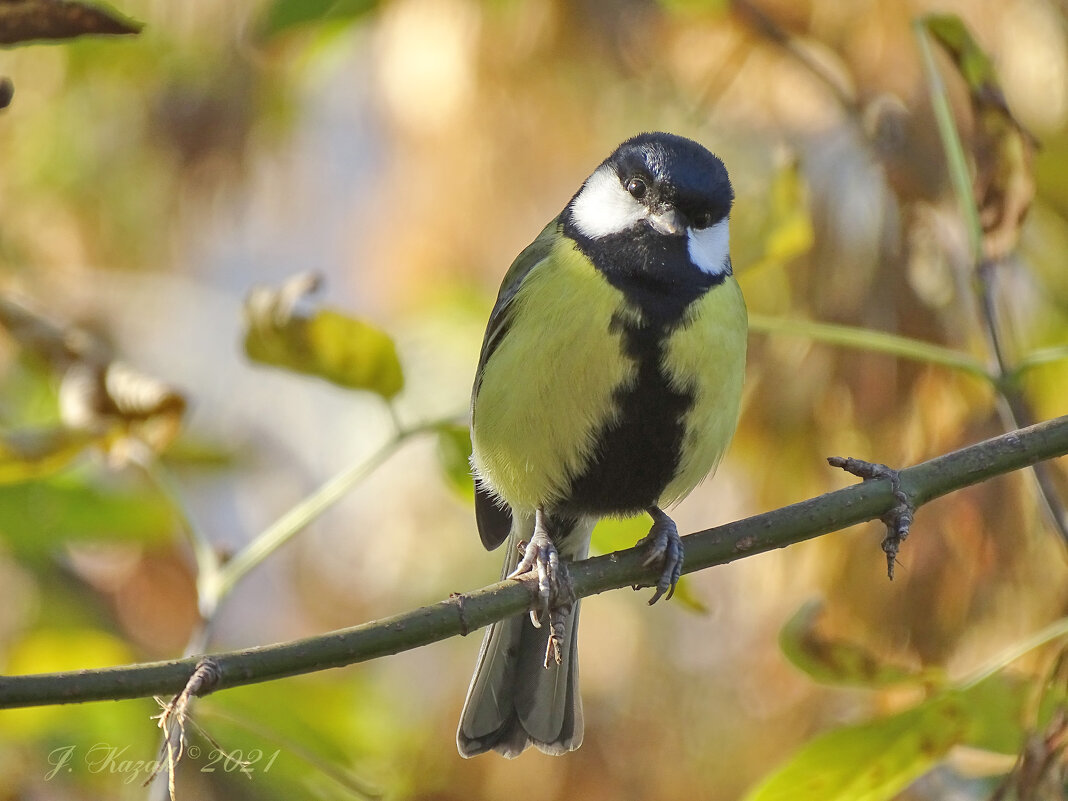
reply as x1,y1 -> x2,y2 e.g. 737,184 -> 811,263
0,415 -> 1068,708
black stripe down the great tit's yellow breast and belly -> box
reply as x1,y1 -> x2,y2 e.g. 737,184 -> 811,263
554,317 -> 693,515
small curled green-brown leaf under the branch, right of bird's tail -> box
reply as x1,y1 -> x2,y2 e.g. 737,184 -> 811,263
779,600 -> 930,688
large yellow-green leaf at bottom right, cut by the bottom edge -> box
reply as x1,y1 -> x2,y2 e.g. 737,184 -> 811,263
745,692 -> 969,801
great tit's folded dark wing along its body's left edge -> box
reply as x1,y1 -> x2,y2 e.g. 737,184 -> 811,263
471,217 -> 560,550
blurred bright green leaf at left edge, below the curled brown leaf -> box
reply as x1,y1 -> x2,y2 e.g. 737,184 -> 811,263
0,475 -> 174,556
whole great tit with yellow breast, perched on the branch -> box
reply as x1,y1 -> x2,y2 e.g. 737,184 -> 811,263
456,134 -> 748,757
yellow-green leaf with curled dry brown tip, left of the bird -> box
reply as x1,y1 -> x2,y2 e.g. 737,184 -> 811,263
245,274 -> 404,399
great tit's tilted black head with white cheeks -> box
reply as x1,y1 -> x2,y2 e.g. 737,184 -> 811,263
562,134 -> 734,316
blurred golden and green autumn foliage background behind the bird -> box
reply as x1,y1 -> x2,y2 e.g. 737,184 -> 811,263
0,0 -> 1068,801
